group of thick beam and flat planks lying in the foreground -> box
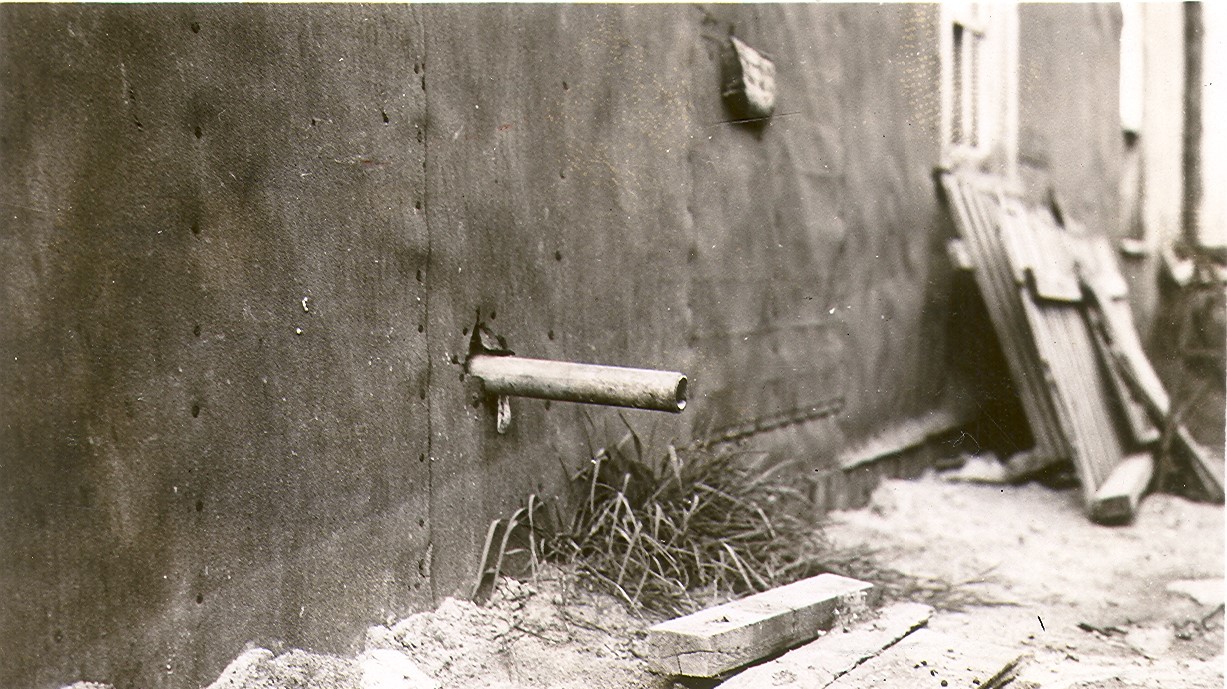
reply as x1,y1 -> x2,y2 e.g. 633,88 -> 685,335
647,574 -> 1025,689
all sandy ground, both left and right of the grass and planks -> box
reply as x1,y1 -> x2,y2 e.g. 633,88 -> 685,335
93,474 -> 1225,689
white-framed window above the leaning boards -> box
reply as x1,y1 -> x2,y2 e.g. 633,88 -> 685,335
941,2 -> 1018,178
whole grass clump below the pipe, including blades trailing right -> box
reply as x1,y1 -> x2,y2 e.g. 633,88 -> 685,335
474,419 -> 1015,615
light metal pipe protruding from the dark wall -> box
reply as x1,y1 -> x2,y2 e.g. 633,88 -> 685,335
467,354 -> 686,413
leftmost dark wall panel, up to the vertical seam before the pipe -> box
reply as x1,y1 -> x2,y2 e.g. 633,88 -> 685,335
0,5 -> 432,687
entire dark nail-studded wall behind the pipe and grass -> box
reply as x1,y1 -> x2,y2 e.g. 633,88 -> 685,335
0,5 -> 1114,687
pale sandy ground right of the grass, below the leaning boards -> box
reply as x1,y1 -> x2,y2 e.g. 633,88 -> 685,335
827,477 -> 1223,689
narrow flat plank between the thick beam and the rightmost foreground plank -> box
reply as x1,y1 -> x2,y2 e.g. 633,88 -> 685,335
720,603 -> 933,689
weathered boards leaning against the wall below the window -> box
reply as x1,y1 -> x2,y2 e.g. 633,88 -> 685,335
941,172 -> 1223,522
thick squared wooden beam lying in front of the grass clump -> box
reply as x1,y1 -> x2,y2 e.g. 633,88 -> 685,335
645,574 -> 877,677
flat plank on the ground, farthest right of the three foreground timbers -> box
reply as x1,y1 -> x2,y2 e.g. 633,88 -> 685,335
827,629 -> 1026,689
